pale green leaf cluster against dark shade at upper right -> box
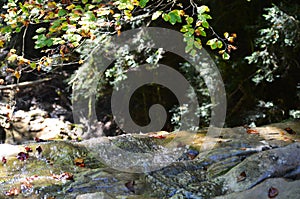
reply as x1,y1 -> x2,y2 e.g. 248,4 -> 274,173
246,5 -> 300,84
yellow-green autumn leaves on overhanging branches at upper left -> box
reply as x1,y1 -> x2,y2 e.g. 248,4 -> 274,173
0,0 -> 233,83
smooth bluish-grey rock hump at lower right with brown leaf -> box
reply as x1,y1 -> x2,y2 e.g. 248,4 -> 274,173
218,143 -> 300,192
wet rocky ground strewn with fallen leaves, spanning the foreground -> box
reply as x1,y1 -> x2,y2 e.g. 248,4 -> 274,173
0,108 -> 300,199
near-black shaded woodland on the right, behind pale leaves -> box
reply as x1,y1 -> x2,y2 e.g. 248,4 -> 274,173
207,1 -> 300,126
